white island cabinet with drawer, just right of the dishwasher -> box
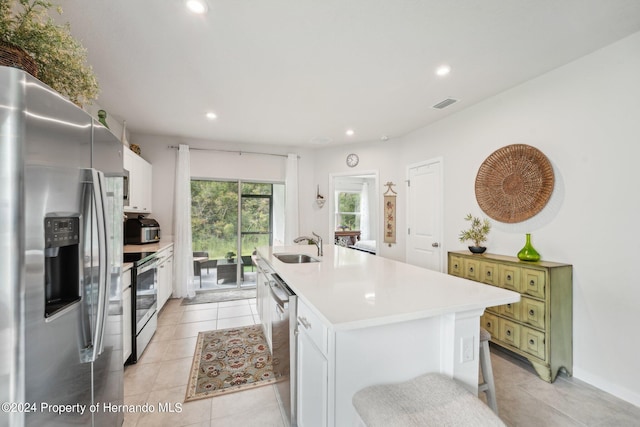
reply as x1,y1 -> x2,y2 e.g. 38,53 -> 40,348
297,300 -> 330,427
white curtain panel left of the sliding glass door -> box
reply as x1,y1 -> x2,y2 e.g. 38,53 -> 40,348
173,144 -> 196,298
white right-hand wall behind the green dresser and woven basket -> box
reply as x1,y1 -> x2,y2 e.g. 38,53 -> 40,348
398,33 -> 640,406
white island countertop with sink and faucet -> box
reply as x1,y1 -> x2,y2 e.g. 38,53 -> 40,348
258,245 -> 520,330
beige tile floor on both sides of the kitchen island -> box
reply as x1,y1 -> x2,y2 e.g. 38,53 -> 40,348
124,299 -> 640,427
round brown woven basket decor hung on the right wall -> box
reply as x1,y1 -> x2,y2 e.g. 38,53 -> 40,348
476,144 -> 554,223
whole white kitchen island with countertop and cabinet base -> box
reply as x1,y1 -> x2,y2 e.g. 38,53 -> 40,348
258,245 -> 520,426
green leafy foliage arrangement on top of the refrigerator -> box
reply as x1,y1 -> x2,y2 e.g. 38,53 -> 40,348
0,0 -> 99,105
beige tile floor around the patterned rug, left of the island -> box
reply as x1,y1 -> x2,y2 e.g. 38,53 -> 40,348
124,299 -> 283,427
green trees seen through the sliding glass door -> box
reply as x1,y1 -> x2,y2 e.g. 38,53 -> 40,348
191,180 -> 272,259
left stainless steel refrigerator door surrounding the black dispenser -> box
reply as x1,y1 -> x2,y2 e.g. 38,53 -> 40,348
21,68 -> 97,426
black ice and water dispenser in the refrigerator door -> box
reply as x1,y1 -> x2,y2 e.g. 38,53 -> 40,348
44,216 -> 80,317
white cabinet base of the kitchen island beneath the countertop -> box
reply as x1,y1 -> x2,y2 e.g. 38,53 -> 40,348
296,298 -> 450,427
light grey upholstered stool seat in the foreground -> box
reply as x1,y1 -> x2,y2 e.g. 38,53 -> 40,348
353,373 -> 504,427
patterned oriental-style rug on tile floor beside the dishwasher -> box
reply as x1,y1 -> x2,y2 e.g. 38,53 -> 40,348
185,325 -> 276,402
